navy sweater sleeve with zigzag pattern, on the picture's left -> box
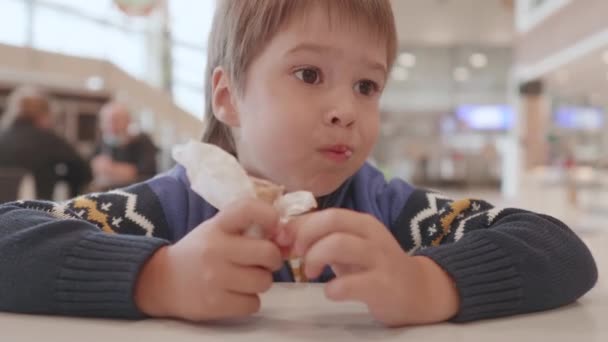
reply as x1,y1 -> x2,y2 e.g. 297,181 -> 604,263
0,183 -> 176,318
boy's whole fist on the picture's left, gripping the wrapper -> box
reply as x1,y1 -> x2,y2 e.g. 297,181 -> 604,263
134,200 -> 283,321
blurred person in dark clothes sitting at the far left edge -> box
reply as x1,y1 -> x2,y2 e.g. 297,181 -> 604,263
0,86 -> 92,200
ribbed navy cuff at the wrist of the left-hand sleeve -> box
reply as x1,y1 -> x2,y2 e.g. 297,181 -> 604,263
54,232 -> 168,318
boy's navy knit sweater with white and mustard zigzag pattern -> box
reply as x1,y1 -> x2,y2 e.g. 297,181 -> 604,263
0,165 -> 597,321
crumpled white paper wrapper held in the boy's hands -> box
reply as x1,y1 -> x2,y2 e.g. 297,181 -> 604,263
173,140 -> 317,282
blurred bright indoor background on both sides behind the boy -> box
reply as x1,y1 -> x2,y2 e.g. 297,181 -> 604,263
0,0 -> 608,229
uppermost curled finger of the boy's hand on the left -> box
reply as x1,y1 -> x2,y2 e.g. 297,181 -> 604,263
215,199 -> 279,237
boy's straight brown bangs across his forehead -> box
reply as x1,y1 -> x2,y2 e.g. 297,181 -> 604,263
226,0 -> 397,87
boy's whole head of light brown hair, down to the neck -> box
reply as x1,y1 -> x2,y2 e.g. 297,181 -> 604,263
203,0 -> 397,155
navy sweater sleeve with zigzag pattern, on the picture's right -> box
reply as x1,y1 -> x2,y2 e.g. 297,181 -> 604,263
391,190 -> 597,321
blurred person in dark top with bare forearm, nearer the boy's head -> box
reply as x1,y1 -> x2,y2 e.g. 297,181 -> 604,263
91,102 -> 158,191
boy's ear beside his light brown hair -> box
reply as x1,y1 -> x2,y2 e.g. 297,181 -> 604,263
211,67 -> 240,127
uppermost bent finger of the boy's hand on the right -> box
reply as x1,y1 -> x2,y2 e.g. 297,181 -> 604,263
287,209 -> 373,256
